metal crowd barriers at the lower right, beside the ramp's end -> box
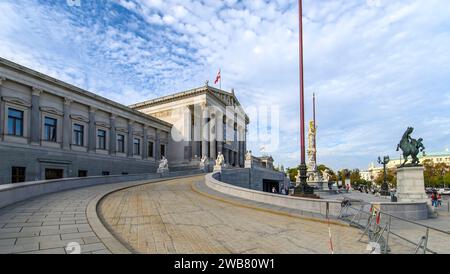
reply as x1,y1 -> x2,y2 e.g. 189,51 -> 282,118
339,201 -> 450,254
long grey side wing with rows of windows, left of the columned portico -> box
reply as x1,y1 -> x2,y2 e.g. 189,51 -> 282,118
0,58 -> 172,184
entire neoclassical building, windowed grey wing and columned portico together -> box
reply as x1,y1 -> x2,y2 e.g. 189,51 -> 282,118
0,58 -> 249,184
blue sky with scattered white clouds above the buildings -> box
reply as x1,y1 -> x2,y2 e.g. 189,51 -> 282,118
0,0 -> 450,169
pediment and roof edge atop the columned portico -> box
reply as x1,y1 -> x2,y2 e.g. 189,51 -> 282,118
129,83 -> 249,122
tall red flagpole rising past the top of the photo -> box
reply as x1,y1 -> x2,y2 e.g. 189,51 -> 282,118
298,0 -> 306,185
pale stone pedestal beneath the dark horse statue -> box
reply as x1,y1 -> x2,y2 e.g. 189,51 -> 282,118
397,166 -> 429,203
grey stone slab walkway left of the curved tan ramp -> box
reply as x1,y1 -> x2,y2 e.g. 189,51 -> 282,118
0,182 -> 142,254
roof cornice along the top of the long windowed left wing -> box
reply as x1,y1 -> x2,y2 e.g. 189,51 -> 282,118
0,57 -> 173,127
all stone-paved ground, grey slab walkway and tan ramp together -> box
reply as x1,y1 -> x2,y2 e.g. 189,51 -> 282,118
0,175 -> 450,254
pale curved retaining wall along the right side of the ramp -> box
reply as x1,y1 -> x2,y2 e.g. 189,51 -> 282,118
205,173 -> 341,217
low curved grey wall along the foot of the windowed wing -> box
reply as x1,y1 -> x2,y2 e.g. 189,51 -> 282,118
0,170 -> 201,208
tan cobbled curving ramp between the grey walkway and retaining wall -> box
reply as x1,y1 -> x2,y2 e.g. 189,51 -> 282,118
99,177 -> 367,254
